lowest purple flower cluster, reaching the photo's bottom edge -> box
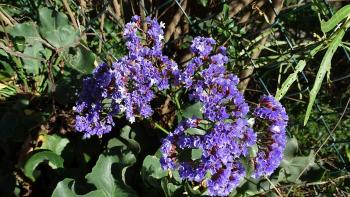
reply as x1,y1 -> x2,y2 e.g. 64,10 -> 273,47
202,119 -> 256,196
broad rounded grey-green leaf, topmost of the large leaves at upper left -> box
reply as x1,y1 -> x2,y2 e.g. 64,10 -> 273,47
39,7 -> 79,48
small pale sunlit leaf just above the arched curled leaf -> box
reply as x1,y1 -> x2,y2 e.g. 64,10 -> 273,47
39,134 -> 69,155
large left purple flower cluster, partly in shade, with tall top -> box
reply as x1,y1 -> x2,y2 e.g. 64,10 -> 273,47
75,16 -> 179,137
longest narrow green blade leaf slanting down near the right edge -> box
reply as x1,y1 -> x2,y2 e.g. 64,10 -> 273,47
304,22 -> 350,125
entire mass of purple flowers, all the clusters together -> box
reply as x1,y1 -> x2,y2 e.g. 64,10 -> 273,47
74,16 -> 288,196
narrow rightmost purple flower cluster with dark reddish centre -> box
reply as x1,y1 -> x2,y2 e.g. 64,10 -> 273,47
252,95 -> 288,178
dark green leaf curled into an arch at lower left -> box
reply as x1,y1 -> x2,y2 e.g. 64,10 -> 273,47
24,150 -> 63,181
